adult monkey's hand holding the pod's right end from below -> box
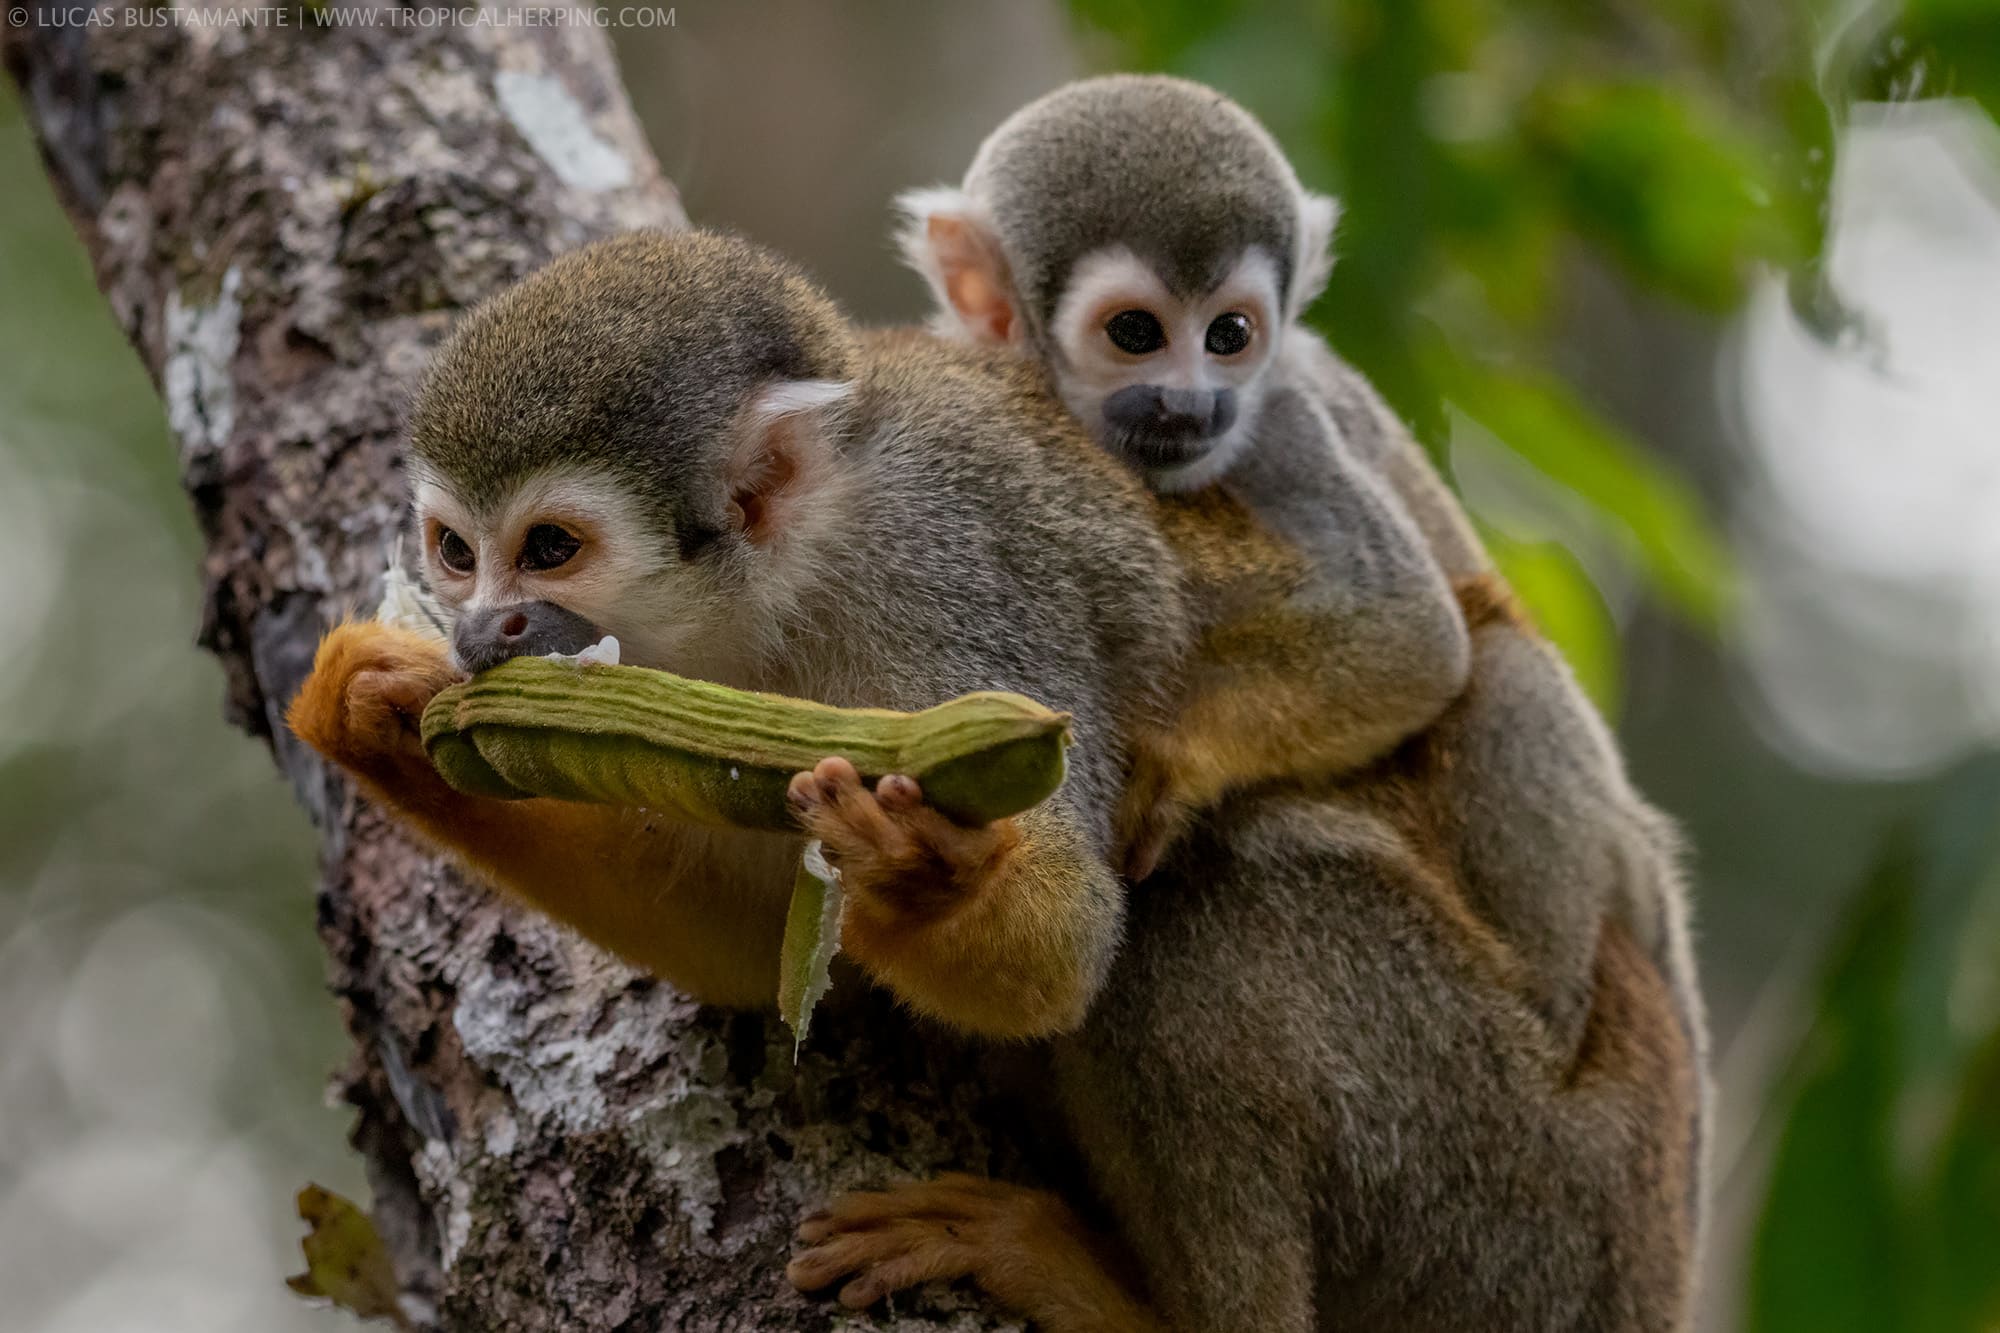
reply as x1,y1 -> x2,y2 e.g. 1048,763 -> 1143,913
790,757 -> 1020,921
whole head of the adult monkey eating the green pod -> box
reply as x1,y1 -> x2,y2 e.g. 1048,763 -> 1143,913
410,232 -> 856,675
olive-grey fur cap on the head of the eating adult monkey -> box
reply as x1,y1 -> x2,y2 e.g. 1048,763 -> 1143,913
410,232 -> 854,550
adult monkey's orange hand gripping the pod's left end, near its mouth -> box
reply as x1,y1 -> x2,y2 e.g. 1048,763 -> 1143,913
286,620 -> 462,797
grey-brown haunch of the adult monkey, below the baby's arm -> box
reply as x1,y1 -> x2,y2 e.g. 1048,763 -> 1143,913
1056,780 -> 1696,1333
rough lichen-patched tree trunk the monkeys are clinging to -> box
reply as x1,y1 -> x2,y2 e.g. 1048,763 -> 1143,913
6,8 -> 1014,1329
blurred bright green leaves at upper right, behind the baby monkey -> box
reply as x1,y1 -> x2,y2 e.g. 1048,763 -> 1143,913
1072,0 -> 2000,684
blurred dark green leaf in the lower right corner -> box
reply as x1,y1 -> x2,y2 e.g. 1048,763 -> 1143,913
1748,761 -> 2000,1333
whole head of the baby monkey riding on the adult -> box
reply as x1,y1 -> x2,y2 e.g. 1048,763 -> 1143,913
900,74 -> 1336,490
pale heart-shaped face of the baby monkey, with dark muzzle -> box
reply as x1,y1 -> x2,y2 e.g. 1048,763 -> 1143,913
1050,246 -> 1284,490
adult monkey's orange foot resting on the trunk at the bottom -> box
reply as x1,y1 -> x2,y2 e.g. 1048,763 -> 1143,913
786,1175 -> 1160,1333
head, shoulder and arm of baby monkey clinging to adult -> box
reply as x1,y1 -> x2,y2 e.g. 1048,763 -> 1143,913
900,76 -> 1468,879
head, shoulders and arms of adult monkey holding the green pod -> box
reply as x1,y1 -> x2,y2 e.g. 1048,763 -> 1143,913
290,232 -> 1180,1037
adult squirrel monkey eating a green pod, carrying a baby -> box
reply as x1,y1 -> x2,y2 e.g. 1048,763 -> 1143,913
290,234 -> 1692,1333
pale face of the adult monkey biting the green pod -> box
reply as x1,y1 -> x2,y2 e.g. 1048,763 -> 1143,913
414,468 -> 736,671
